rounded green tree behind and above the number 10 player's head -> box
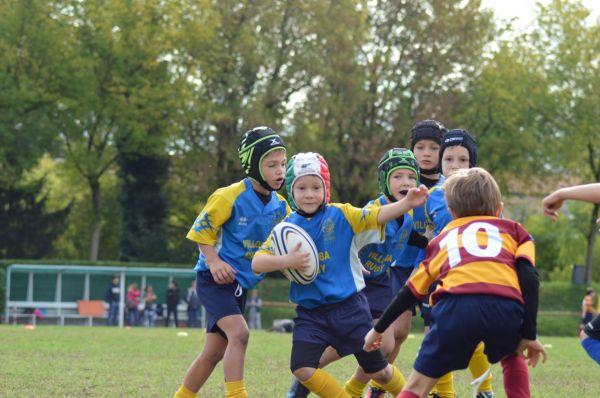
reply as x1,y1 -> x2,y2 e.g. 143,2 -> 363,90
453,36 -> 557,191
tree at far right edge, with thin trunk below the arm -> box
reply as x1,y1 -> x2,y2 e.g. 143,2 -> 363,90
532,0 -> 600,282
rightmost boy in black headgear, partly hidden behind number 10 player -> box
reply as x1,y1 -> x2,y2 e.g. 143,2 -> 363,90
425,129 -> 496,398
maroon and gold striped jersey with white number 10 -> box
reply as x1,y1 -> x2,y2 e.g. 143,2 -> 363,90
407,216 -> 535,305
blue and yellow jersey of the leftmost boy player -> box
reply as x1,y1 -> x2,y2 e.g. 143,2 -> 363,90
187,178 -> 290,289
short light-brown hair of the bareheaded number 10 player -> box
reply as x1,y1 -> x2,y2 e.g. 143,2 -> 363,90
443,167 -> 502,218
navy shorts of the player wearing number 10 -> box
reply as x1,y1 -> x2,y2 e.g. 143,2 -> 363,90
413,294 -> 523,378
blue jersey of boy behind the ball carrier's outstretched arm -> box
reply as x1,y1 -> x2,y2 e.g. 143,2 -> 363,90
358,195 -> 413,279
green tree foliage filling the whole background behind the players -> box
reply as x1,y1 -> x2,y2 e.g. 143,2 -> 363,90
0,0 -> 600,279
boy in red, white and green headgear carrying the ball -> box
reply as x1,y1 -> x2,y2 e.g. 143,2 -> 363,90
252,153 -> 427,397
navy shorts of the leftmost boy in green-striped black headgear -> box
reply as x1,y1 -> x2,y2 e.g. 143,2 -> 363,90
196,270 -> 248,337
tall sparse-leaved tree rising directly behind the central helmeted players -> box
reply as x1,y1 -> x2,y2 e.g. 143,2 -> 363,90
294,1 -> 493,204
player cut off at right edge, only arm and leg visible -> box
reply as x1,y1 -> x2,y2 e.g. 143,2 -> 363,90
542,183 -> 600,365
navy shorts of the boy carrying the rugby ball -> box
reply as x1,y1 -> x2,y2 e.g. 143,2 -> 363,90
293,292 -> 373,363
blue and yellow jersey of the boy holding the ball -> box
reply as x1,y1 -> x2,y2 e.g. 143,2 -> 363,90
258,203 -> 385,309
